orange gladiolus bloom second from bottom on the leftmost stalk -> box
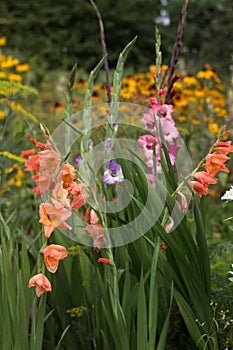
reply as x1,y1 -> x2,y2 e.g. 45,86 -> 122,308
42,244 -> 68,273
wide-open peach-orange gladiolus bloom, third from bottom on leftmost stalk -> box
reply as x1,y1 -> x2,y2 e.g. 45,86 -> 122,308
39,203 -> 71,238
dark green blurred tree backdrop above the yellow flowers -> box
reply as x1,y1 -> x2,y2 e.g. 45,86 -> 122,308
0,0 -> 233,82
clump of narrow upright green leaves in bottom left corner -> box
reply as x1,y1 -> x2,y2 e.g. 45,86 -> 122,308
0,213 -> 46,350
